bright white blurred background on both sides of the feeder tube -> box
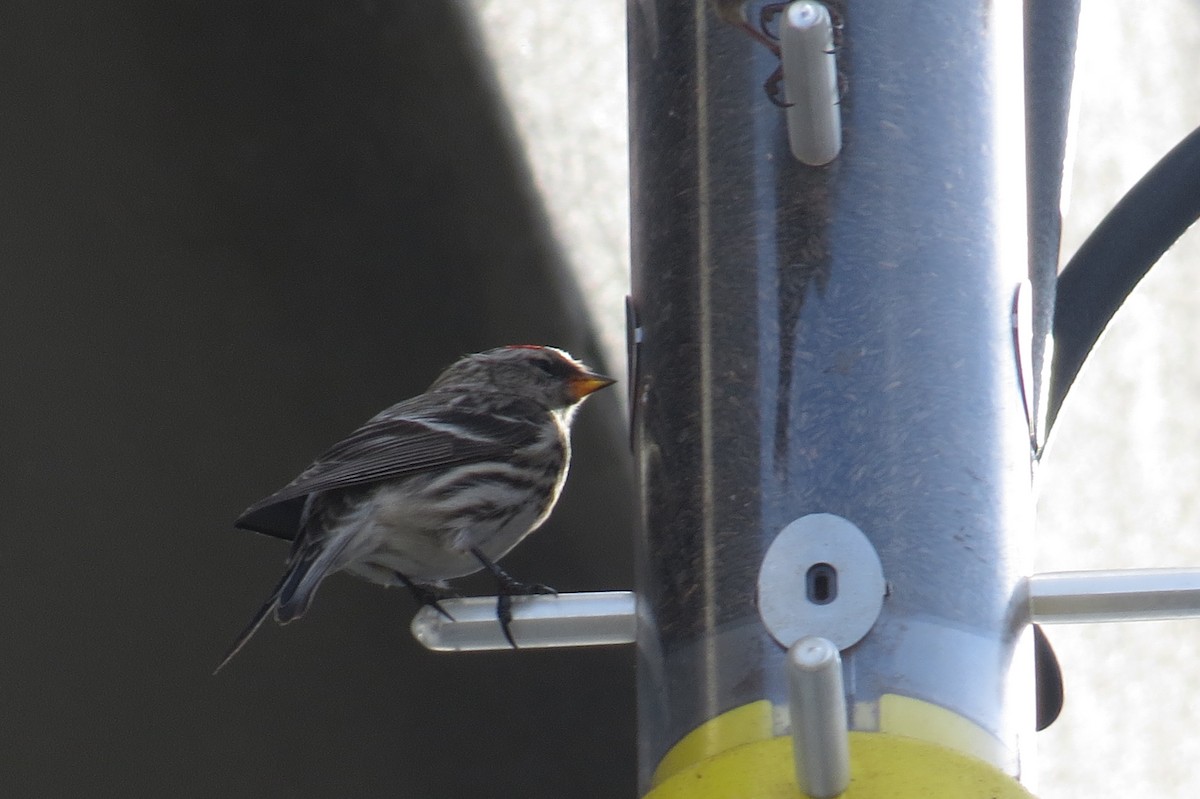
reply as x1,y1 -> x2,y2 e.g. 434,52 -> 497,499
460,0 -> 1200,799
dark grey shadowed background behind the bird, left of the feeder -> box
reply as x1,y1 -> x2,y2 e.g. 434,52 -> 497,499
0,0 -> 635,798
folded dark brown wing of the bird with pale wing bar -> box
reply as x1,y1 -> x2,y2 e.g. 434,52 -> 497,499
234,409 -> 539,539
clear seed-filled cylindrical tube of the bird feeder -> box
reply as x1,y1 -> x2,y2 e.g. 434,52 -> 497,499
629,0 -> 1033,791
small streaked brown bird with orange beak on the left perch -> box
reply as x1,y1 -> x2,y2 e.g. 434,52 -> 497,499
214,344 -> 616,673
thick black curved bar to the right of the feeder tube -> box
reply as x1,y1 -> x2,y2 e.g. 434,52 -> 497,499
1046,128 -> 1200,432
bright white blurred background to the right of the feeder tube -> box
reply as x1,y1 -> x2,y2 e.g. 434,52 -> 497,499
1037,0 -> 1200,799
